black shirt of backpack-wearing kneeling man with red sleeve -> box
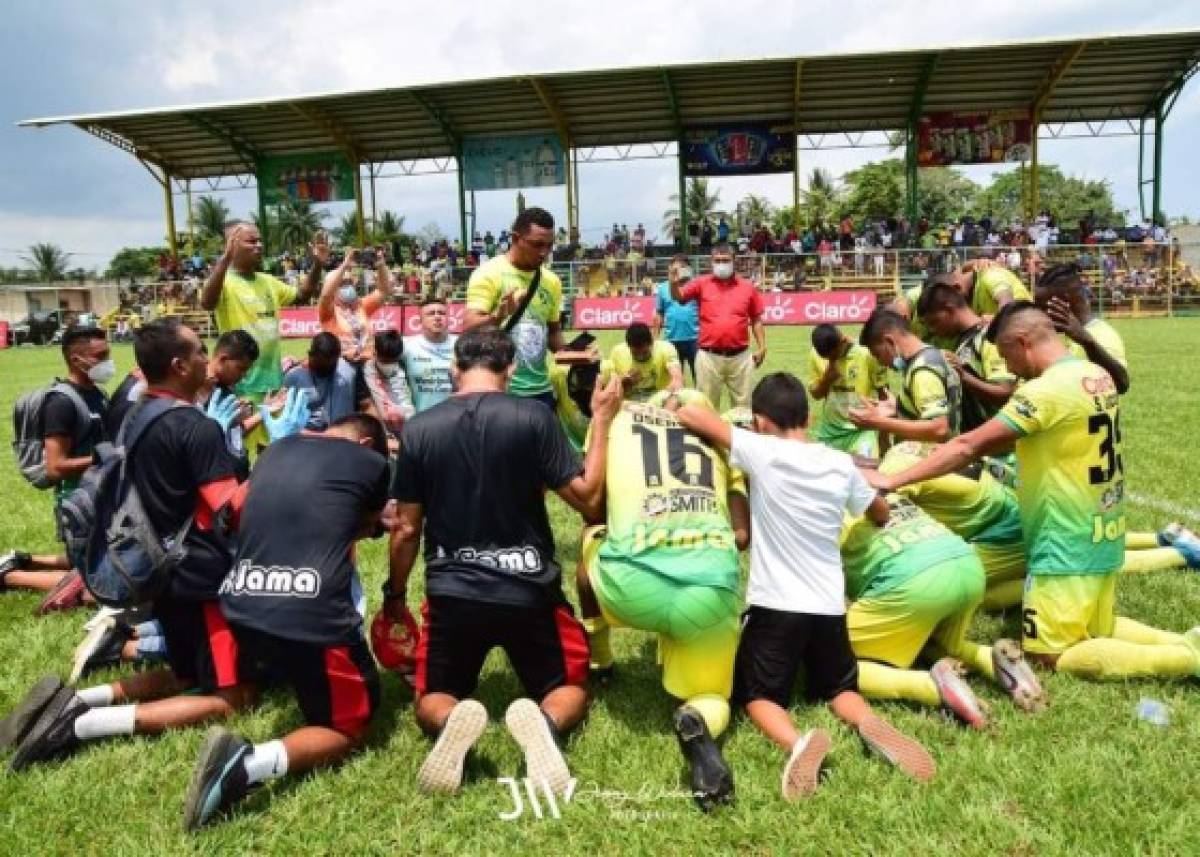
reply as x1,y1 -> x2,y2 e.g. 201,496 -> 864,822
127,404 -> 234,601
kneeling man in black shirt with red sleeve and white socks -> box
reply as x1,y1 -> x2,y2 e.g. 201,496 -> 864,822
10,319 -> 253,771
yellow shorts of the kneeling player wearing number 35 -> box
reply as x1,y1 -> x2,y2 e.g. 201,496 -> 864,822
1021,574 -> 1117,654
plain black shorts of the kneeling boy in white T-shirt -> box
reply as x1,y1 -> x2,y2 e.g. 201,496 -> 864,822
733,607 -> 858,708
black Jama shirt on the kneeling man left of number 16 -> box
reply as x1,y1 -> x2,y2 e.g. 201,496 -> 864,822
391,392 -> 582,606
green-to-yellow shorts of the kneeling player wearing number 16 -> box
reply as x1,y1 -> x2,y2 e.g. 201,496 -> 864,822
581,527 -> 739,700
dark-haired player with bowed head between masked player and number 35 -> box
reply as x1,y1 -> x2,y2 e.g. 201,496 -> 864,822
917,286 -> 1016,431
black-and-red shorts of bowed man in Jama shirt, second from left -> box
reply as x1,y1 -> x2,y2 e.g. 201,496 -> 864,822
233,625 -> 379,738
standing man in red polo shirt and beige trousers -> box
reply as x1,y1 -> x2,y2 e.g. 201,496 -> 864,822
668,241 -> 767,412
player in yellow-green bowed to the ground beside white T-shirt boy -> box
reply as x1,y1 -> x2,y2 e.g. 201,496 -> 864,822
841,495 -> 1045,729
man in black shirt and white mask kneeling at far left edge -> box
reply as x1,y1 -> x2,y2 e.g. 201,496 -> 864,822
0,328 -> 113,615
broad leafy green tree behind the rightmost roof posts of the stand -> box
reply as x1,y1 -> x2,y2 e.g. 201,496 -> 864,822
976,163 -> 1128,227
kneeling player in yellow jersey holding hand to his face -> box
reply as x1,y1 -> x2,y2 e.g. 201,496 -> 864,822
808,324 -> 888,457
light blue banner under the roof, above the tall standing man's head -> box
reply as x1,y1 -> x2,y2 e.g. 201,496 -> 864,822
462,132 -> 566,191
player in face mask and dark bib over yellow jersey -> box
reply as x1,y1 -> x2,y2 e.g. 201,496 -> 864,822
850,310 -> 962,445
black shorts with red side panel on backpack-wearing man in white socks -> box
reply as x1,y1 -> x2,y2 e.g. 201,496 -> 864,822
154,598 -> 240,691
